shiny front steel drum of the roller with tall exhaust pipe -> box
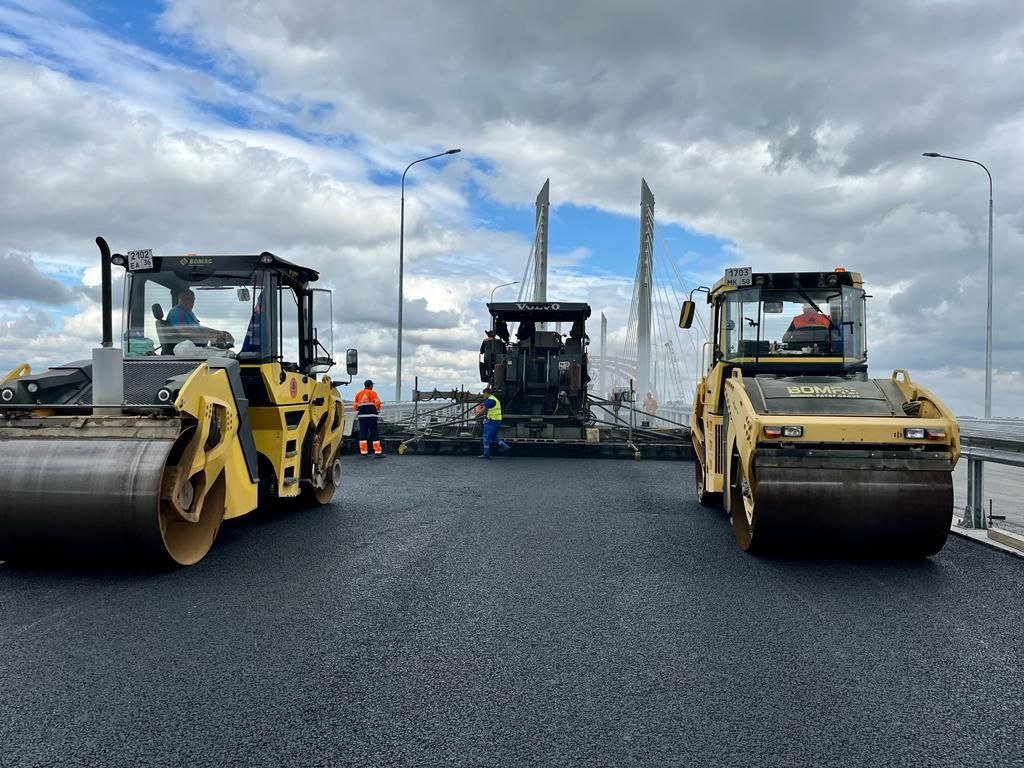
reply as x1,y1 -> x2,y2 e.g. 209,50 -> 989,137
0,437 -> 191,564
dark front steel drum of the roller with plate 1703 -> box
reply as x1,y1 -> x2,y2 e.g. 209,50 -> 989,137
739,467 -> 953,556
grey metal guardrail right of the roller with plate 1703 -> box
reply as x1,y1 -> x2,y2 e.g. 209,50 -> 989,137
958,419 -> 1024,528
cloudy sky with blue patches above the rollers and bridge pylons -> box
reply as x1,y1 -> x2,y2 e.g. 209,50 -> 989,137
0,0 -> 1024,416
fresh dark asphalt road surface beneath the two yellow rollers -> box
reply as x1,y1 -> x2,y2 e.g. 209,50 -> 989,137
0,456 -> 1024,768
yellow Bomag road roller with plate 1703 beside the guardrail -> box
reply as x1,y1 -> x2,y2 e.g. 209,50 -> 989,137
680,267 -> 959,557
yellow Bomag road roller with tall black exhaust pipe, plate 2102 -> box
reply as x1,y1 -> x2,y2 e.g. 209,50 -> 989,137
0,238 -> 357,565
